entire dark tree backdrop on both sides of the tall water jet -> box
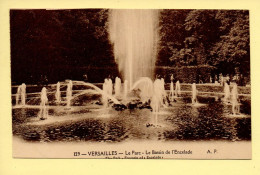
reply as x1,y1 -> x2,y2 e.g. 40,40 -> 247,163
10,9 -> 250,83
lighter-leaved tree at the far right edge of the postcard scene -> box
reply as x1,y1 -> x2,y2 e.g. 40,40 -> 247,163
209,11 -> 250,76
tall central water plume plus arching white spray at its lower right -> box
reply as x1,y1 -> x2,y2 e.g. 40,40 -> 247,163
109,9 -> 167,118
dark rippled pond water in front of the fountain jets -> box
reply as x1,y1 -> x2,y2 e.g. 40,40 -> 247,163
12,97 -> 251,142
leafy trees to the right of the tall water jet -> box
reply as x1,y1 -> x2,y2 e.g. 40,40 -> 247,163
157,10 -> 250,79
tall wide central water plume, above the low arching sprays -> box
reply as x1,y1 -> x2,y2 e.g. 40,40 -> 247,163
109,9 -> 159,89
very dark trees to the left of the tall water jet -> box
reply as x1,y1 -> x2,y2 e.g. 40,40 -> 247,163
10,9 -> 116,83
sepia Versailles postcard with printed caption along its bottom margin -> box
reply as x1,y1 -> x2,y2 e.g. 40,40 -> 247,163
9,8 -> 252,159
